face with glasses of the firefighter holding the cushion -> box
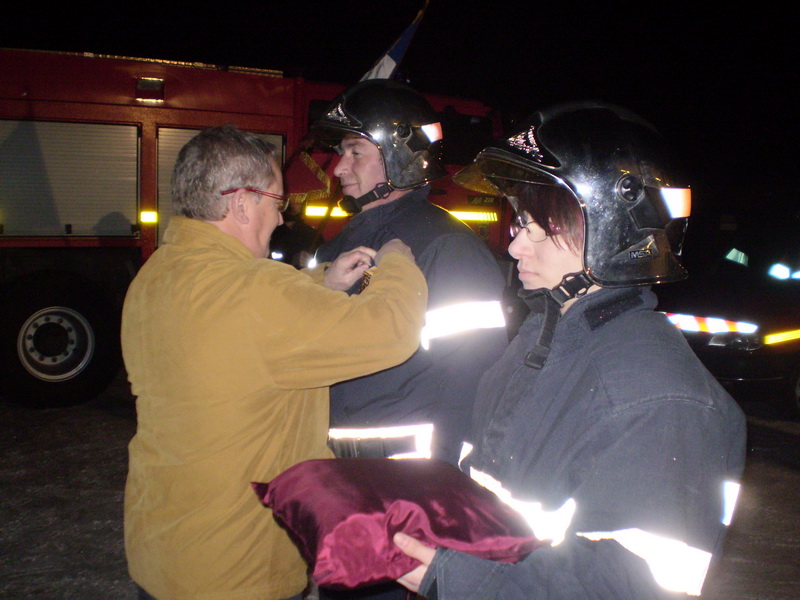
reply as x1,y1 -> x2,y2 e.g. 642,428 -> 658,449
508,212 -> 583,290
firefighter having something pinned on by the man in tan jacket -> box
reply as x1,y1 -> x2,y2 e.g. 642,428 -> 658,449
311,80 -> 508,464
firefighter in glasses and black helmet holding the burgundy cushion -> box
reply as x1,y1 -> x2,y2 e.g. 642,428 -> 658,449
395,103 -> 745,600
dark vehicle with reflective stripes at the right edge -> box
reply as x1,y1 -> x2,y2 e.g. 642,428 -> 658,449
655,213 -> 800,419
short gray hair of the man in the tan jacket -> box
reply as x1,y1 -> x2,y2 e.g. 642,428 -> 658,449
172,125 -> 275,221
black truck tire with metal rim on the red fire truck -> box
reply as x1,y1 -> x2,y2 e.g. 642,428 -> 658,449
0,273 -> 121,408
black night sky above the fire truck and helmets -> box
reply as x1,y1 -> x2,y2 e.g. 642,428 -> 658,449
0,0 -> 800,220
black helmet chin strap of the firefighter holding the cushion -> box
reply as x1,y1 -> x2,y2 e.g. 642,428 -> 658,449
519,271 -> 593,369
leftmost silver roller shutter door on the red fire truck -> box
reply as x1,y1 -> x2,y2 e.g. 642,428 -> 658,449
0,121 -> 138,236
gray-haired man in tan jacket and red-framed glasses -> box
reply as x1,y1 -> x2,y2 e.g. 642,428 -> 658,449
122,126 -> 427,600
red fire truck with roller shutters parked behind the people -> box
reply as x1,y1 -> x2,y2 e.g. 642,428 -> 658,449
0,49 -> 508,407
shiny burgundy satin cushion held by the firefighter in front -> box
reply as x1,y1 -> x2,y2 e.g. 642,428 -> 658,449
253,458 -> 537,589
